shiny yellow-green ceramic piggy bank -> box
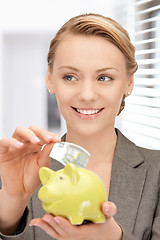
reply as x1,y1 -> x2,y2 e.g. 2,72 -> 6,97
38,163 -> 106,225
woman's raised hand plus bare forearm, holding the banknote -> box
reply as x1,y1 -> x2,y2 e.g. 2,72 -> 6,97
0,126 -> 60,234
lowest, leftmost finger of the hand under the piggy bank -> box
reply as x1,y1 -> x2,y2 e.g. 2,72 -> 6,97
29,218 -> 59,239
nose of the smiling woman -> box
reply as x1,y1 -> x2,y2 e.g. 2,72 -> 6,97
79,80 -> 98,101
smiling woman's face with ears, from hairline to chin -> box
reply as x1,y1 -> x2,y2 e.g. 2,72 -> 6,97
47,34 -> 133,138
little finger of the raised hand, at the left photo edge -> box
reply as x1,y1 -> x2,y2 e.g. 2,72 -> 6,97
0,138 -> 23,153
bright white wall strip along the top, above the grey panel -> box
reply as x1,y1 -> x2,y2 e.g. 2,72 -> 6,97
0,0 -> 117,32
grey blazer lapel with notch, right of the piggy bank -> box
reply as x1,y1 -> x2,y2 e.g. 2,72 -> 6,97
109,130 -> 146,231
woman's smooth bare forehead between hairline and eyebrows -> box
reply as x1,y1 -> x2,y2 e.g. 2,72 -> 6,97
54,34 -> 126,69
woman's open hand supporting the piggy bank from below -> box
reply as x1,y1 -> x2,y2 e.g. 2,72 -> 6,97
30,202 -> 122,240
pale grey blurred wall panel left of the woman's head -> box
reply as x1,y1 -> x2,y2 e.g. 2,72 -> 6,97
3,34 -> 48,136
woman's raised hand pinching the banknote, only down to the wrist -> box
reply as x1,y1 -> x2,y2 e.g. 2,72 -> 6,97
0,126 -> 60,200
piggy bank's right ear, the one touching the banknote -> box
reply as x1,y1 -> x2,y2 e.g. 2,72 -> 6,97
64,163 -> 80,184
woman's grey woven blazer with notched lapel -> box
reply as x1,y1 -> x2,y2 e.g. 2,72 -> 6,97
0,130 -> 160,240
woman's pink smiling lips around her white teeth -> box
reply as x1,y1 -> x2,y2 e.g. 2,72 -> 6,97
72,107 -> 104,120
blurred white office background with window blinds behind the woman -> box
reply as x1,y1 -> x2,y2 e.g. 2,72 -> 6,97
0,0 -> 160,149
